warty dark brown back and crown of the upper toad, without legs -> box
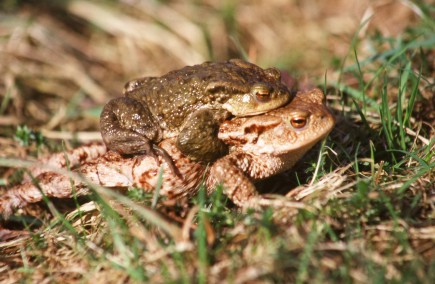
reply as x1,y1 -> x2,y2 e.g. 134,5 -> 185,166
124,60 -> 288,130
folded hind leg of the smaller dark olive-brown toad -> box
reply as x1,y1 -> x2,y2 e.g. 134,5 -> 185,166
100,97 -> 179,175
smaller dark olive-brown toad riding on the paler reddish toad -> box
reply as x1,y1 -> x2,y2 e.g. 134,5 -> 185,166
100,59 -> 291,168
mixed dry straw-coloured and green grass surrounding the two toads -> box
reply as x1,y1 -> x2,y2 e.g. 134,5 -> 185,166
0,0 -> 435,283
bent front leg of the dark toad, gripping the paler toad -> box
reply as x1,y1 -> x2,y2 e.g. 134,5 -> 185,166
177,109 -> 230,162
